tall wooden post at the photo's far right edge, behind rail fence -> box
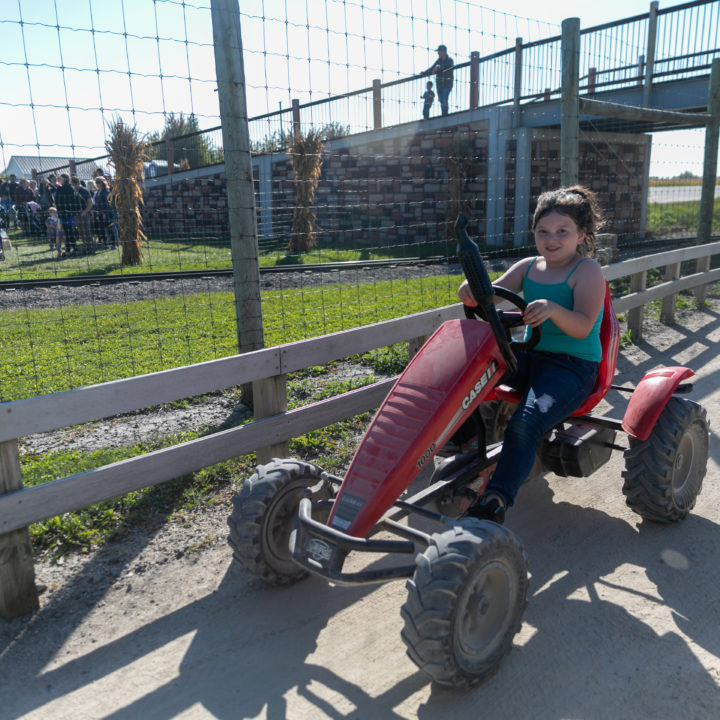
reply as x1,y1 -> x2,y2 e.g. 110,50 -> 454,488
695,58 -> 720,305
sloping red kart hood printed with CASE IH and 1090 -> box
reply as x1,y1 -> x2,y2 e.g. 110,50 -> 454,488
328,320 -> 506,537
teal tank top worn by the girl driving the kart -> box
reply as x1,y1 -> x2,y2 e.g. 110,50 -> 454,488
522,258 -> 603,362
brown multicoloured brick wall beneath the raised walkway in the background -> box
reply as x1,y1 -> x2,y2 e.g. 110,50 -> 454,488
143,122 -> 649,247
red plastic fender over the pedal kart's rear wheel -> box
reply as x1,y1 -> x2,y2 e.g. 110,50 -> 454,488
622,367 -> 695,440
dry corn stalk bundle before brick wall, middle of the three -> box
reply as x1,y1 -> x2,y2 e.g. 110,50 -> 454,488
287,129 -> 323,254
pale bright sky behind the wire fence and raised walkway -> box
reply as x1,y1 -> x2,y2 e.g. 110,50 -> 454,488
0,0 -> 704,176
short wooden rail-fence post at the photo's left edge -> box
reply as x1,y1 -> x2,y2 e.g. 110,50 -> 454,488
0,440 -> 39,620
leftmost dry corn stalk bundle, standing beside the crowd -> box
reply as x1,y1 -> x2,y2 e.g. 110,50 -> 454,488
105,118 -> 147,265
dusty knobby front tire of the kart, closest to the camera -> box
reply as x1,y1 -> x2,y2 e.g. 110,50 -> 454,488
401,520 -> 528,687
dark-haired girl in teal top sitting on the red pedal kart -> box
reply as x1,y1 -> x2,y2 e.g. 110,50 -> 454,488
458,186 -> 605,523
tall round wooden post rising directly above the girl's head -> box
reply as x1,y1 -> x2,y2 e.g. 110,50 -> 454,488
560,18 -> 580,187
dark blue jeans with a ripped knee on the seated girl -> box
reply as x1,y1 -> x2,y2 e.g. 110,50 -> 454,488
485,350 -> 599,507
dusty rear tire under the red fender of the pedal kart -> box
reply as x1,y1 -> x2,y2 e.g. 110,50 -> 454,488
623,397 -> 710,523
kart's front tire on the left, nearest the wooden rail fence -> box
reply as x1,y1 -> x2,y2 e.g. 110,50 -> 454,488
228,459 -> 332,585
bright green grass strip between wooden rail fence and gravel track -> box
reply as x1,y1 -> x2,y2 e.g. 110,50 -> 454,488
0,276 -> 460,401
